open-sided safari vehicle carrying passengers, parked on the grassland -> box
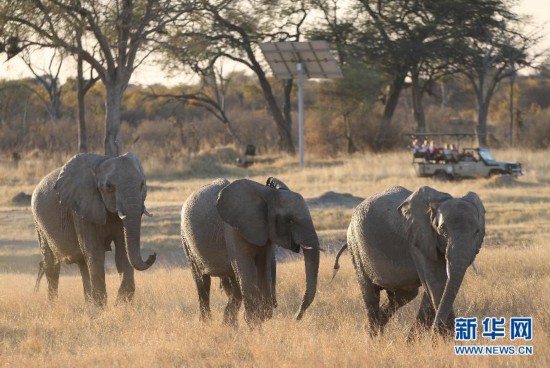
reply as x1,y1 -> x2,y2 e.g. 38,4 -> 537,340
411,134 -> 523,180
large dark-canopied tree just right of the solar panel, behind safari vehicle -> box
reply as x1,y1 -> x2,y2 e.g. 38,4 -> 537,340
356,0 -> 540,149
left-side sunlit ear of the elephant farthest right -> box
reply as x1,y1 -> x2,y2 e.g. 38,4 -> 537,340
398,187 -> 452,261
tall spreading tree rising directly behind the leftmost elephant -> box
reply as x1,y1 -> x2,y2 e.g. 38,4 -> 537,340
0,0 -> 194,156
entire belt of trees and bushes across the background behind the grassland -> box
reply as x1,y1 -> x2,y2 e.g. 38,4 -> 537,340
0,0 -> 550,157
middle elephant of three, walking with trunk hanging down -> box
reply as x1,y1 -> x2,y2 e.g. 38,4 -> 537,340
181,178 -> 320,328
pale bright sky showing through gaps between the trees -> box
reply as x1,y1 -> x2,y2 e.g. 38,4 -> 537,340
0,0 -> 550,85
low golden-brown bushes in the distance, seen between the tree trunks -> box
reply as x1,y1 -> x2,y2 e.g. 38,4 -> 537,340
0,69 -> 550,158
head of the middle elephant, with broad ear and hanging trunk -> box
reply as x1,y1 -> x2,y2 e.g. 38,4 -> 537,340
217,179 -> 320,319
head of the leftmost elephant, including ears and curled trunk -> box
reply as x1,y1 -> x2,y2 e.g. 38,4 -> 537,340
55,152 -> 156,270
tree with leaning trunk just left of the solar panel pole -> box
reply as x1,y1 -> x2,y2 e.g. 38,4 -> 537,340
164,0 -> 308,154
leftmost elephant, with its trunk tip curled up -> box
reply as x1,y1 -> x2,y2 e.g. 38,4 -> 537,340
31,152 -> 156,307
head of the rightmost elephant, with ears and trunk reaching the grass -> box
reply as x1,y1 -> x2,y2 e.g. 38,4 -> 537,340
399,187 -> 485,328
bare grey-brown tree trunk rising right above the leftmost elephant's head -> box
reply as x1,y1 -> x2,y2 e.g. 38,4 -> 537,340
105,82 -> 123,157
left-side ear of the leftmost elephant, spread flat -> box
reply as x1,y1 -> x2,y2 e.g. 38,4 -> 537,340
55,153 -> 108,225
